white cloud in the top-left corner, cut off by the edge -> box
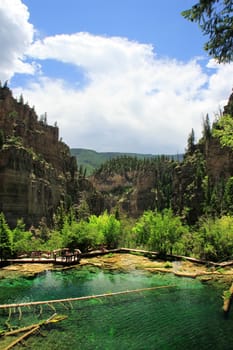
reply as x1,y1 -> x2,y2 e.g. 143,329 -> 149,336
0,0 -> 34,82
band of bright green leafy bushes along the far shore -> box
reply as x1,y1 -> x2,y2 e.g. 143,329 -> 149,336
0,209 -> 233,261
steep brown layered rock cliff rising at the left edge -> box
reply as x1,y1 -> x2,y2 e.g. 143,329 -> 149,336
0,87 -> 77,226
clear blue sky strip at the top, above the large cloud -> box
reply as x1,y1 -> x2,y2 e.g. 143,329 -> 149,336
24,0 -> 204,60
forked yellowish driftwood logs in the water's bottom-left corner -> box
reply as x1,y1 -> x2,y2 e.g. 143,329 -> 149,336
0,314 -> 67,350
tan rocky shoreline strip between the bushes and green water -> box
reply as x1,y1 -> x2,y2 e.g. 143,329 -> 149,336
0,253 -> 233,283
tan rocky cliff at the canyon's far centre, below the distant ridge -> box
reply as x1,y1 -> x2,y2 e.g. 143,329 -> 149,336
90,160 -> 175,218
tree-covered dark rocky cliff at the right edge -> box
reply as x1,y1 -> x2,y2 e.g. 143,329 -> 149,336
172,94 -> 233,224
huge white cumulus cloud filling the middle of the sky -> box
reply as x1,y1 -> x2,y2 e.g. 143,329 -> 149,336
16,33 -> 233,153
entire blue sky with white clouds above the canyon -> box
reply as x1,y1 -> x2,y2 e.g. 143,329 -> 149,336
0,0 -> 233,154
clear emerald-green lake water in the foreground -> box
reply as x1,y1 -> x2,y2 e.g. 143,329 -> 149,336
0,268 -> 233,350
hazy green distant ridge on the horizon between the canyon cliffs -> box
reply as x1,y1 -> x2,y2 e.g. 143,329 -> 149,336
70,148 -> 183,175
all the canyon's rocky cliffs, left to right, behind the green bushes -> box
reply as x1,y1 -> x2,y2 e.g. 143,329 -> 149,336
0,86 -> 233,227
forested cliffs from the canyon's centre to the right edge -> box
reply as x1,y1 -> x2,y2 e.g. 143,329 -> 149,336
91,91 -> 233,224
